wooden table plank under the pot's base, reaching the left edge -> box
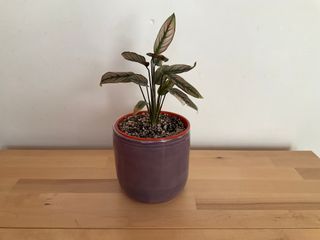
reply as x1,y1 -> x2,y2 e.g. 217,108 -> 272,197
0,192 -> 196,211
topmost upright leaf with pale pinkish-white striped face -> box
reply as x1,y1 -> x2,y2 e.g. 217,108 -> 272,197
153,13 -> 176,54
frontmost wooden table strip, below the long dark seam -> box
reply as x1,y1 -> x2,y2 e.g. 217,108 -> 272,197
0,229 -> 320,240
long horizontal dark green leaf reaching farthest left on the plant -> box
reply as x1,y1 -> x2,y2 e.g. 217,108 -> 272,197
100,72 -> 148,86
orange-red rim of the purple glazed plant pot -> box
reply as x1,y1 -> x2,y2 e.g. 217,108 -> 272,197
113,111 -> 190,142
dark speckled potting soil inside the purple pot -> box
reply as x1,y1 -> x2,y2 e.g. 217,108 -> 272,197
119,113 -> 186,138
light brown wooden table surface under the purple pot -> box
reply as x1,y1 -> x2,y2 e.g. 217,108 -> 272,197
0,150 -> 320,240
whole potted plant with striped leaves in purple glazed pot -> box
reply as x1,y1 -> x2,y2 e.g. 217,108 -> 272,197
100,14 -> 202,203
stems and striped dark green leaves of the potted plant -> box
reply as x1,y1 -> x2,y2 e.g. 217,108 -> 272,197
100,14 -> 202,124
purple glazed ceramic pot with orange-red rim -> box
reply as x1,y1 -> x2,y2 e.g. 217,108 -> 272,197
113,111 -> 190,203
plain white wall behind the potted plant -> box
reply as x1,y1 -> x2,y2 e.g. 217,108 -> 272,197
0,0 -> 320,156
